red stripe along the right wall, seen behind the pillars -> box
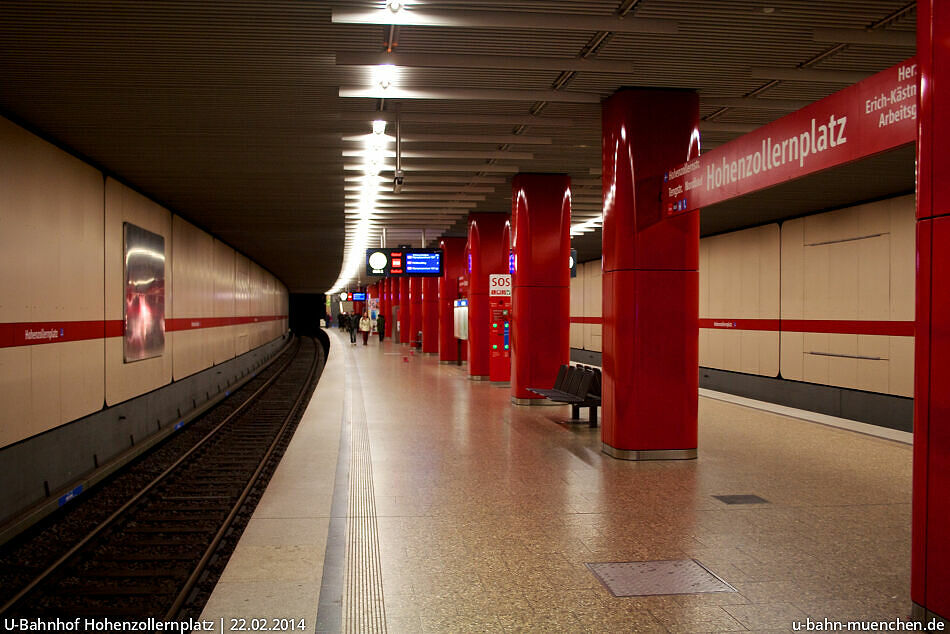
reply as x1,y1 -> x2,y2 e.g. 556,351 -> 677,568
571,317 -> 914,337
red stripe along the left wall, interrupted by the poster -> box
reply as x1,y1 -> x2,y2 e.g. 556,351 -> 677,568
0,315 -> 287,348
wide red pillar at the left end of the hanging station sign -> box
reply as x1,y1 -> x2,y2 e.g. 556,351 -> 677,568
602,89 -> 699,460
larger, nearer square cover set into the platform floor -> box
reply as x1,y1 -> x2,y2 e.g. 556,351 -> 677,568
587,559 -> 736,597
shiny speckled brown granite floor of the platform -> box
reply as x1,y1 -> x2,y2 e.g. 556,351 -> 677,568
214,334 -> 911,632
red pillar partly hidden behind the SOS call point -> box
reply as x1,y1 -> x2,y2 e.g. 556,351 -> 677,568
468,213 -> 508,381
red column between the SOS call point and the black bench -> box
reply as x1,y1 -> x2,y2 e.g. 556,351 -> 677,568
511,174 -> 571,405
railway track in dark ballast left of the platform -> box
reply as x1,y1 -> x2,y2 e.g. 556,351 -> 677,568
0,338 -> 323,620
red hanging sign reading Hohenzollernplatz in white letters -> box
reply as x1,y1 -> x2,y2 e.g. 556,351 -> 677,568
663,58 -> 918,215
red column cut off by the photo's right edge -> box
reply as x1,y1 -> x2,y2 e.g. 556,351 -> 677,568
910,0 -> 950,620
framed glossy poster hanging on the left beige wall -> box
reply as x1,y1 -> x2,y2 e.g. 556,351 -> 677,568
122,222 -> 165,363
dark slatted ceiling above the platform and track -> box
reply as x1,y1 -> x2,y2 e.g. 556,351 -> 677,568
0,0 -> 916,292
